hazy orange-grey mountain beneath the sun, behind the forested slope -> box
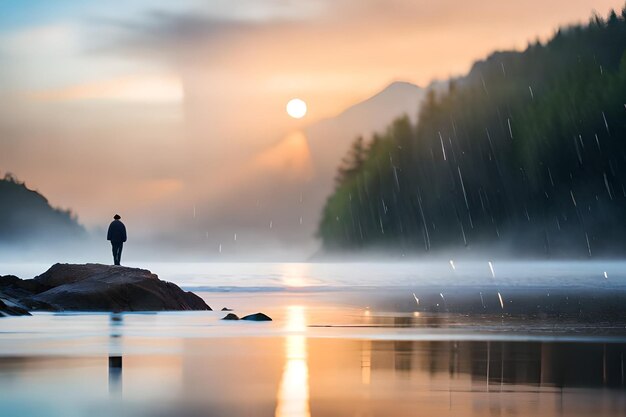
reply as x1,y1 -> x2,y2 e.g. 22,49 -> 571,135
190,82 -> 425,259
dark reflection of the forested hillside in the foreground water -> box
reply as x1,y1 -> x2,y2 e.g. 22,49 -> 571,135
358,340 -> 626,391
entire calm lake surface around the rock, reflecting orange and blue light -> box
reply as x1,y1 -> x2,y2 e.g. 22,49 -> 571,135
0,260 -> 626,417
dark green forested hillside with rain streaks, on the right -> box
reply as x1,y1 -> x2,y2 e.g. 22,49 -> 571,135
318,8 -> 626,257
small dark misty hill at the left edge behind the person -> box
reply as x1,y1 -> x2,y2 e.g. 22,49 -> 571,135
0,174 -> 86,249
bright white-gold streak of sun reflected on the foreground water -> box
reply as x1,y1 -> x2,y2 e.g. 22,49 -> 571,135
276,306 -> 311,417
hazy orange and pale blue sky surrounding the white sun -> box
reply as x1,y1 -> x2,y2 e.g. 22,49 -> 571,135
0,0 -> 623,258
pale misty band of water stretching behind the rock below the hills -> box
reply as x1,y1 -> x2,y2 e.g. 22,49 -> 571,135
2,259 -> 626,291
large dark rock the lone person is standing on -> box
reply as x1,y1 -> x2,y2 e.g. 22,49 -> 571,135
0,264 -> 211,311
